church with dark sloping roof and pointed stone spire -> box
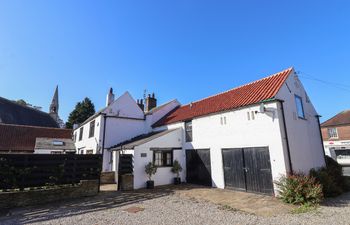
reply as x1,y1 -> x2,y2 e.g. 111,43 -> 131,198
0,87 -> 63,127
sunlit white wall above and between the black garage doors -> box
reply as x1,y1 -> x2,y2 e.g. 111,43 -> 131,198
163,102 -> 287,192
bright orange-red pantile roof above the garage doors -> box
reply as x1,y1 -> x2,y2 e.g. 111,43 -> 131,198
153,68 -> 293,127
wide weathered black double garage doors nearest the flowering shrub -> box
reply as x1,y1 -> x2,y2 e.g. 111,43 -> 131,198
222,147 -> 273,194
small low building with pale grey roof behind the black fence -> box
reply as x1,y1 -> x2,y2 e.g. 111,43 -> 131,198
34,137 -> 75,154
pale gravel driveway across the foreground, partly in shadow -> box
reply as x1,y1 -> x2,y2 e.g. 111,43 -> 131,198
0,185 -> 350,225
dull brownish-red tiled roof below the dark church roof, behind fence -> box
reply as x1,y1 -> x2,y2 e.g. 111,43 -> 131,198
0,124 -> 72,153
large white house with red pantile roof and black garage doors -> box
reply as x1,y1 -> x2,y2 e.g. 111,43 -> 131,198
75,68 -> 325,194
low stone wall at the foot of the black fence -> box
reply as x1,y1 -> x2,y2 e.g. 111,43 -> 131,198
0,180 -> 98,209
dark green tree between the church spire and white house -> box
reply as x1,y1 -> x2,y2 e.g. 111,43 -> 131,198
66,98 -> 95,129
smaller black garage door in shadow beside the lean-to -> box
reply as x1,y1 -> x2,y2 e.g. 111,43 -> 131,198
186,149 -> 212,186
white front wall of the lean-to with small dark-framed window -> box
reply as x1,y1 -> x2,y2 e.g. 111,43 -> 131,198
129,129 -> 186,189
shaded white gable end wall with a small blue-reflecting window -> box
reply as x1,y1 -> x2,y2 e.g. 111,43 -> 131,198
276,71 -> 325,173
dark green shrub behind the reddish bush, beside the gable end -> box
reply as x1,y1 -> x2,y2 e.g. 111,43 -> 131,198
310,156 -> 347,197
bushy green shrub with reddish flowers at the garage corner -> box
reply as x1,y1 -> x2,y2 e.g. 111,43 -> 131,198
276,174 -> 323,205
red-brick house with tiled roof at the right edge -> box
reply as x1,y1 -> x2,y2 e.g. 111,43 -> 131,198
321,110 -> 350,175
